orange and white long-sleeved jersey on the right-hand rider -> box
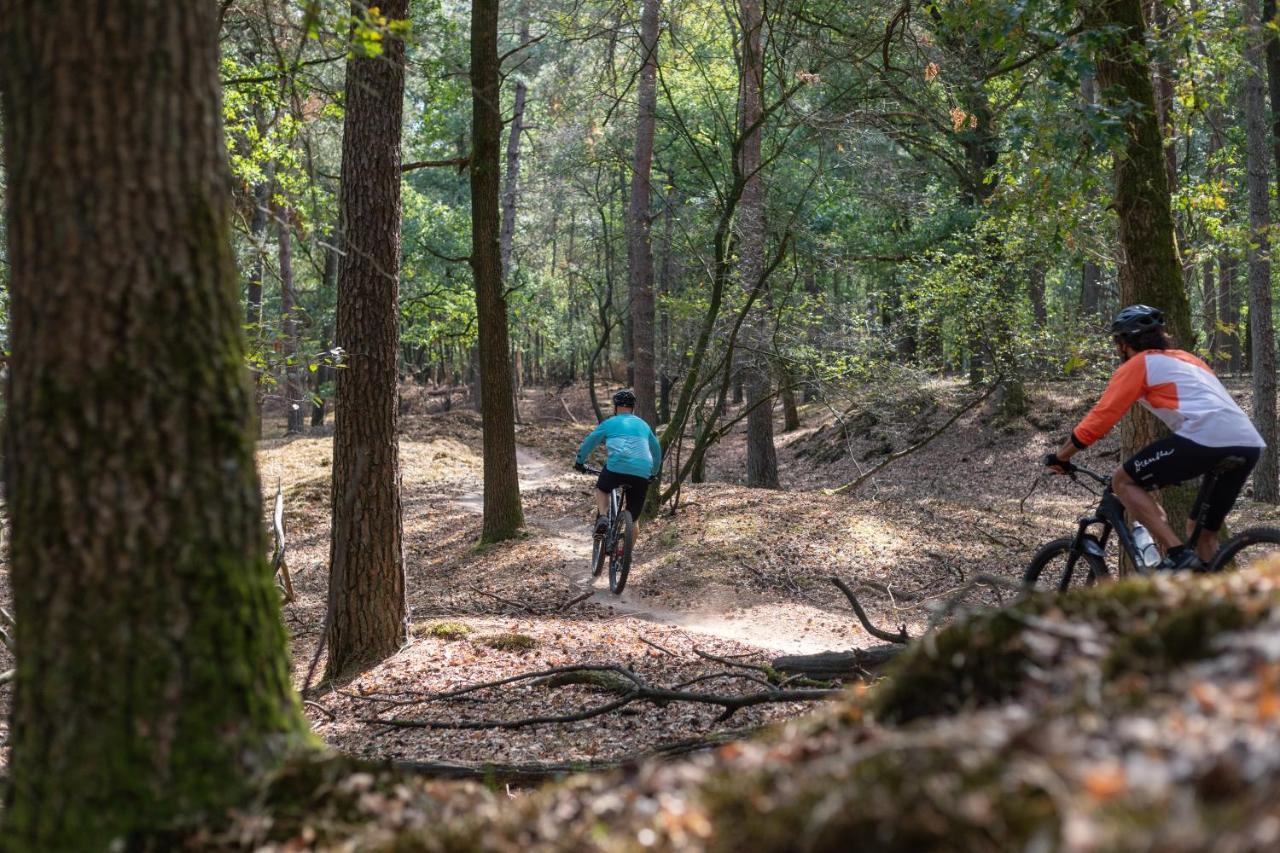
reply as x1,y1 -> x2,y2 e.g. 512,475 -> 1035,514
1071,350 -> 1266,448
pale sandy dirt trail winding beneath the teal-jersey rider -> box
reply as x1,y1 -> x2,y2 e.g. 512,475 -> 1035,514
457,447 -> 860,654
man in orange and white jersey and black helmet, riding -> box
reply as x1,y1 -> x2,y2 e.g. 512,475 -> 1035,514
1044,305 -> 1266,570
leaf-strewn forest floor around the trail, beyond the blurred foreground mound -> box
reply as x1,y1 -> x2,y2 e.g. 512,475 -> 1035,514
249,371 -> 1280,765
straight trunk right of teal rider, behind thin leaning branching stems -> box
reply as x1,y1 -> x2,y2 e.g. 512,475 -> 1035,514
739,0 -> 780,489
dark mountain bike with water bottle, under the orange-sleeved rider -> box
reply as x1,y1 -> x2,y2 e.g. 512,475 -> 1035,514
1023,456 -> 1280,592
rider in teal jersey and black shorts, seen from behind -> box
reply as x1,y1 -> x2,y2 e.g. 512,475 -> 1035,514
573,391 -> 662,535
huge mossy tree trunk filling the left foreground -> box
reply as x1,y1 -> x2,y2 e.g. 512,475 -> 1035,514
0,0 -> 307,850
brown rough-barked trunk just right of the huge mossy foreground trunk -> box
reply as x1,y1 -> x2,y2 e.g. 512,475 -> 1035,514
325,0 -> 408,679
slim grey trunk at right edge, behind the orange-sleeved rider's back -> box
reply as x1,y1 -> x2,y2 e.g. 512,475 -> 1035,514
1244,0 -> 1280,503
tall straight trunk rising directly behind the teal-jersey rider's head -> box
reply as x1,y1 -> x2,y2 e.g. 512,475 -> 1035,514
627,0 -> 658,427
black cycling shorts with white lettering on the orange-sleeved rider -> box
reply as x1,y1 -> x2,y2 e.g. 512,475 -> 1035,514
1124,435 -> 1262,530
